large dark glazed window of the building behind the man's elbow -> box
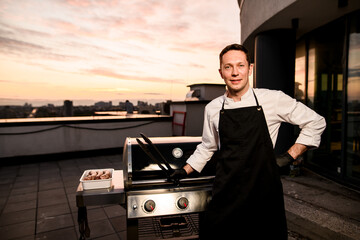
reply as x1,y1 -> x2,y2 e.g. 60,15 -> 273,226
295,11 -> 360,187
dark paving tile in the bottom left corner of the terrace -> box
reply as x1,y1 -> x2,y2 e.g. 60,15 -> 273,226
0,221 -> 35,239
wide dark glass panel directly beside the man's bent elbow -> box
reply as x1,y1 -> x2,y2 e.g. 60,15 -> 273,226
307,17 -> 345,175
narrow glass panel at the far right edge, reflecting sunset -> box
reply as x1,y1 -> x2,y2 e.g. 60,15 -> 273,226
346,12 -> 360,183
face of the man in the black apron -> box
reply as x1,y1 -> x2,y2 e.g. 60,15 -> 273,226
219,50 -> 252,96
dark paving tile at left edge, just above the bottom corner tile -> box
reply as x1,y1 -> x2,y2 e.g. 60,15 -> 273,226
0,208 -> 36,226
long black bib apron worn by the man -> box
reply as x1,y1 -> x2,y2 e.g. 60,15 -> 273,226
200,92 -> 287,240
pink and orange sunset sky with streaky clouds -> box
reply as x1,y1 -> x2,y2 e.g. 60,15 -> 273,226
0,0 -> 240,106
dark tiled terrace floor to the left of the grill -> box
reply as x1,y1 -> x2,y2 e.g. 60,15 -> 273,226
0,155 -> 126,240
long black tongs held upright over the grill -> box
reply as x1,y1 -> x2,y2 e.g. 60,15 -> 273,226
136,133 -> 174,180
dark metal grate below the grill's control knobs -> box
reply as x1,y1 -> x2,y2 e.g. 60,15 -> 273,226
138,214 -> 199,240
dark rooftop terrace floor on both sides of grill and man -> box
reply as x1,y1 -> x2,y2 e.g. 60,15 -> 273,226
0,154 -> 360,240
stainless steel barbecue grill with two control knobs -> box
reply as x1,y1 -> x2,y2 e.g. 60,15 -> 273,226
123,134 -> 215,239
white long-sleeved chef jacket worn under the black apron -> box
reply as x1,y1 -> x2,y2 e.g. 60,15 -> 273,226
187,88 -> 326,172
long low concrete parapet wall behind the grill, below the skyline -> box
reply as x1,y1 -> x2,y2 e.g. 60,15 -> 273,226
0,117 -> 172,158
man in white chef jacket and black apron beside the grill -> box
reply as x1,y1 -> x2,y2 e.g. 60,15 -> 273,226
173,44 -> 326,240
